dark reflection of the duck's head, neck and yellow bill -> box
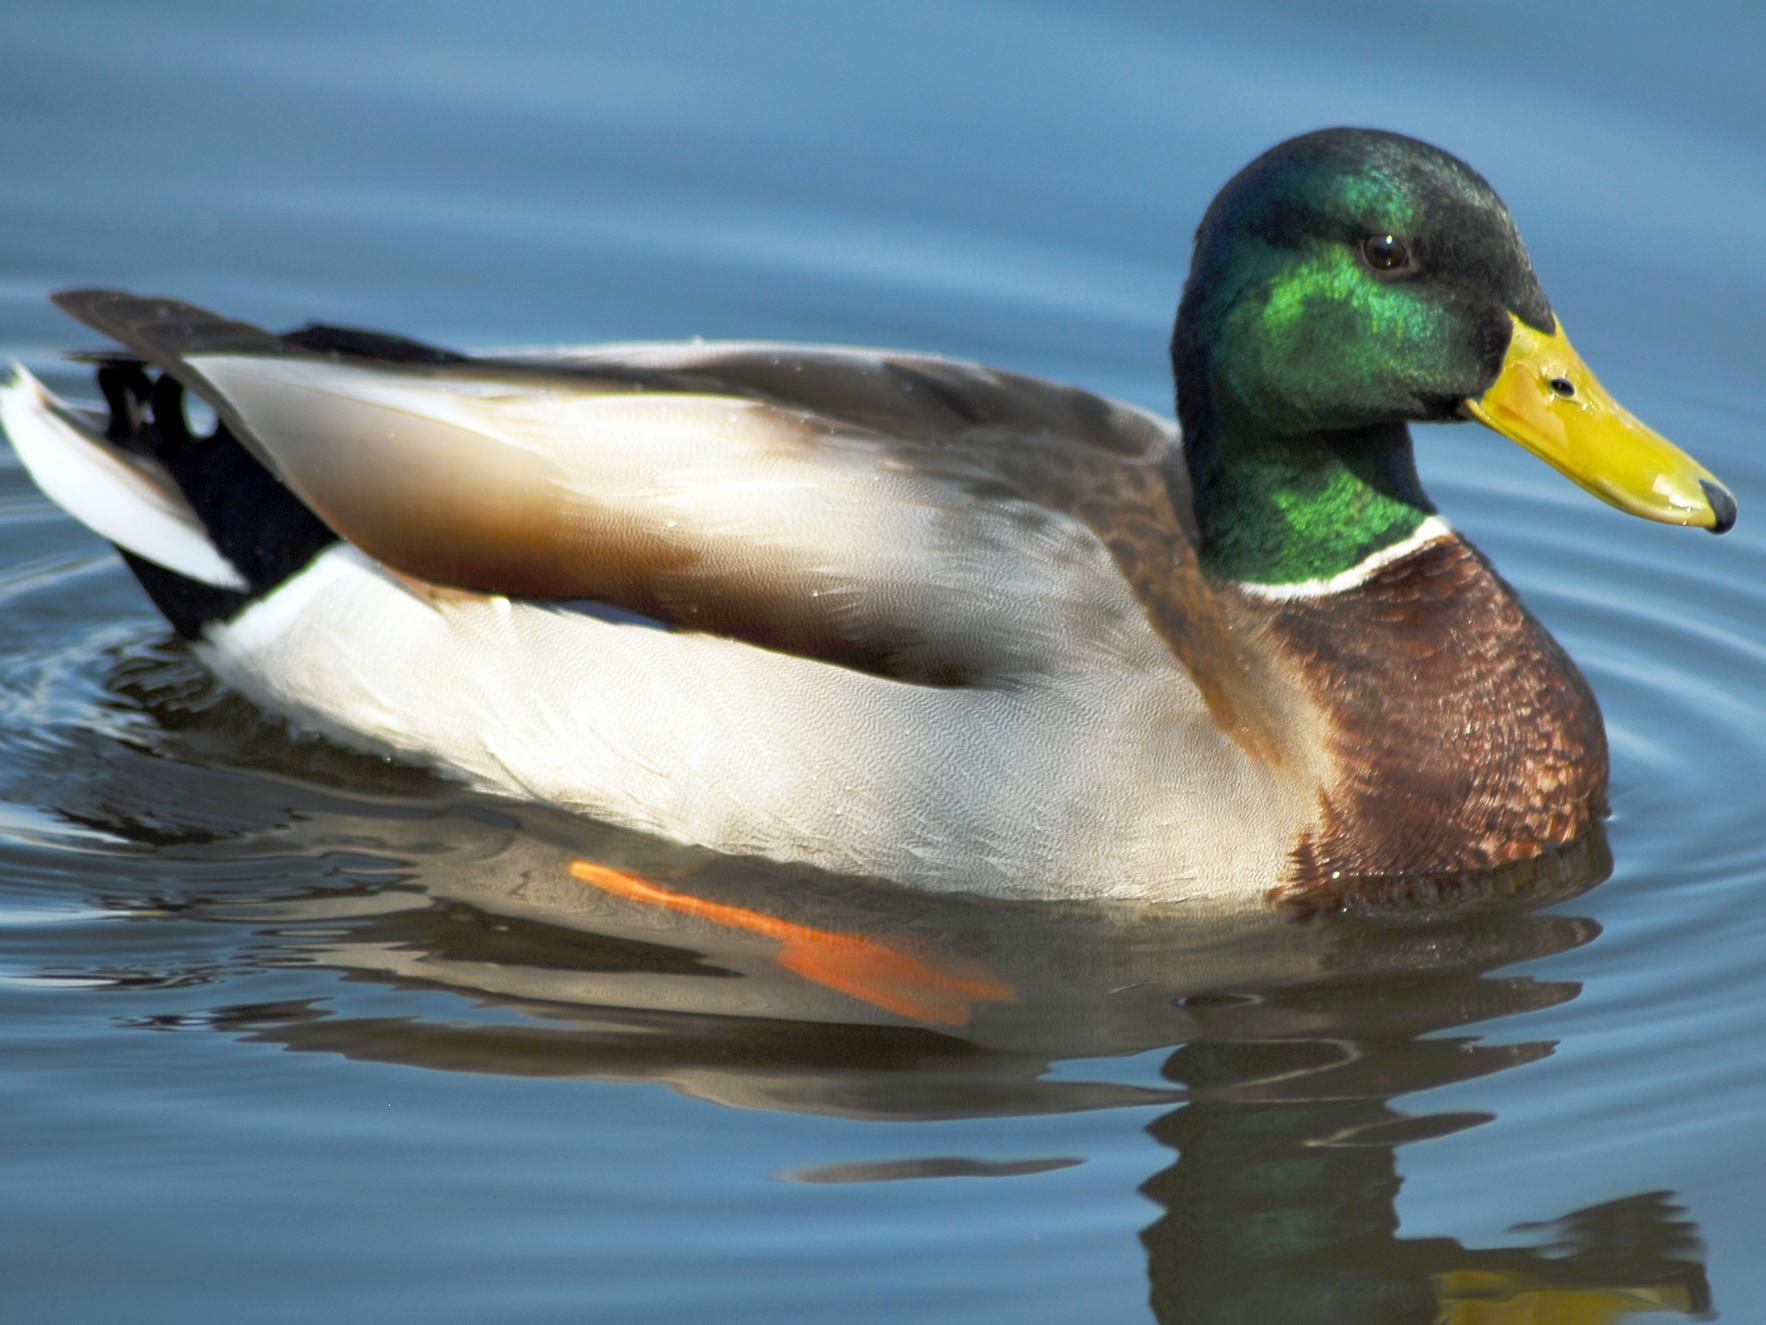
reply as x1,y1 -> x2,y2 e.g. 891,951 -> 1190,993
1141,1003 -> 1709,1325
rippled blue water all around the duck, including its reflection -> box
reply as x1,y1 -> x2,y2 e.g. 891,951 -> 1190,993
0,0 -> 1766,1325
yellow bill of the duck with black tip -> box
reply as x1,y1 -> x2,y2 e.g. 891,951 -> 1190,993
1460,313 -> 1736,534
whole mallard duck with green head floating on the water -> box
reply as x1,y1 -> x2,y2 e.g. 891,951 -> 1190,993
0,129 -> 1736,906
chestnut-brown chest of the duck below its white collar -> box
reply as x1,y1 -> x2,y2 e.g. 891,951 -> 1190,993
1268,537 -> 1607,910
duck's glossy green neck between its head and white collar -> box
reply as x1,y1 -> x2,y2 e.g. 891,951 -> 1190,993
1178,365 -> 1434,587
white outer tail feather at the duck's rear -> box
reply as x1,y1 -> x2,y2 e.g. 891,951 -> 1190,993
0,364 -> 249,590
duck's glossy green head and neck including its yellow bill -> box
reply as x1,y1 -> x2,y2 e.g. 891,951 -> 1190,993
1171,129 -> 1736,583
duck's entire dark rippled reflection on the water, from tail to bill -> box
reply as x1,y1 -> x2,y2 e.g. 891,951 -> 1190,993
0,643 -> 1711,1325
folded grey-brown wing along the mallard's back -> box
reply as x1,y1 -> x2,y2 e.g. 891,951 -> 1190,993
58,292 -> 1192,685
